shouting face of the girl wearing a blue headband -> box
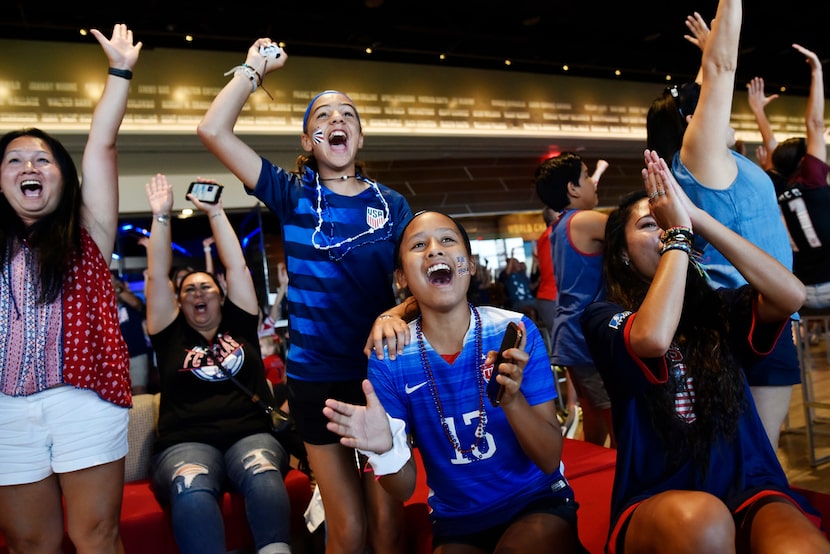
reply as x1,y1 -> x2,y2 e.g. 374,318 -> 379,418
301,92 -> 363,171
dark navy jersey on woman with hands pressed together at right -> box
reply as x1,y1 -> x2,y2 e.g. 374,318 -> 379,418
582,286 -> 824,548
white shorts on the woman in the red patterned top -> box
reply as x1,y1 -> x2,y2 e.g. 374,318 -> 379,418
0,386 -> 129,485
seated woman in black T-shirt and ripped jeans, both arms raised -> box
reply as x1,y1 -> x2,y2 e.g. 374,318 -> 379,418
145,174 -> 291,554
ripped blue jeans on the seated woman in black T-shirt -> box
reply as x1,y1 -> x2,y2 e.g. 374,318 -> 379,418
151,433 -> 290,554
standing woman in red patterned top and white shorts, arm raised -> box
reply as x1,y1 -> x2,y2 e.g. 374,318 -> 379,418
0,24 -> 141,553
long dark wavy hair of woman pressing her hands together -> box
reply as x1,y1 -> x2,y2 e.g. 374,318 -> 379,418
603,191 -> 747,471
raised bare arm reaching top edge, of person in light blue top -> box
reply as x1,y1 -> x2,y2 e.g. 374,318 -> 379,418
680,0 -> 742,189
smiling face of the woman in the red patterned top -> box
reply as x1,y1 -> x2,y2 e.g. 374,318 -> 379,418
0,135 -> 63,226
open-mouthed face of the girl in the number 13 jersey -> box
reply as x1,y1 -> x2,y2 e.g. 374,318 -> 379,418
397,212 -> 476,311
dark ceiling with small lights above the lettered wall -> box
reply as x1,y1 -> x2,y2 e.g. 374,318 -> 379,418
0,0 -> 830,95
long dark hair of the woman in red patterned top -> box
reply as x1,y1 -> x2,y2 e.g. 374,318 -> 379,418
0,129 -> 81,303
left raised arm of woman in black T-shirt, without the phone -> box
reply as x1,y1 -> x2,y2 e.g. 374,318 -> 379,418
144,173 -> 179,335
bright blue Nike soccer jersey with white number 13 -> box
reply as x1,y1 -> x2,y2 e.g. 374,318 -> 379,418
369,307 -> 573,535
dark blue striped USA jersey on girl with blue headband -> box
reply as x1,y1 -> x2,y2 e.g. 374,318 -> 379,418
252,158 -> 412,381
